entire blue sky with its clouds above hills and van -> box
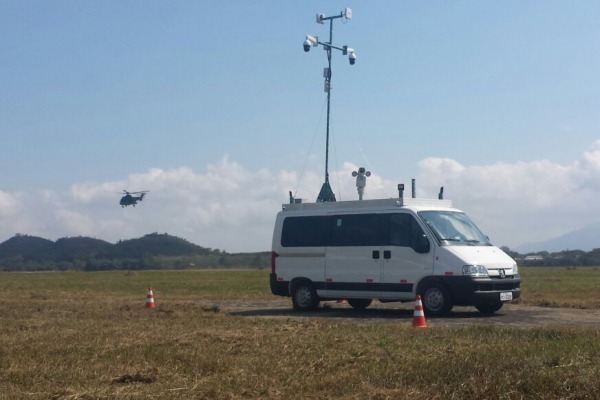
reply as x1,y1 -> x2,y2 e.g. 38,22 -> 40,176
0,0 -> 600,252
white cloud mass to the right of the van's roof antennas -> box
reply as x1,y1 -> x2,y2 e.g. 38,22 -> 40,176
419,141 -> 600,247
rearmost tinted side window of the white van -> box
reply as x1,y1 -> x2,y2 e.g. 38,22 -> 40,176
281,216 -> 327,247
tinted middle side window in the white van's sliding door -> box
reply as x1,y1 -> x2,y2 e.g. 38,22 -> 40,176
329,214 -> 384,246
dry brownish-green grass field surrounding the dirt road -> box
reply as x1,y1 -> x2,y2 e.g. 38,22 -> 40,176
0,268 -> 600,400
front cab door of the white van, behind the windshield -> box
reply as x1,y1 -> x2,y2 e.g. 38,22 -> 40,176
382,213 -> 434,300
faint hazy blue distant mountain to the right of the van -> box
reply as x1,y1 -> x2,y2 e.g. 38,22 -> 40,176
512,223 -> 600,254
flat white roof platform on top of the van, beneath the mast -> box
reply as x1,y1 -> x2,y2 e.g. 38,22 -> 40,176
282,197 -> 453,211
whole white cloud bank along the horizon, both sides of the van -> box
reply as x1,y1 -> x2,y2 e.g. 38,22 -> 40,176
0,145 -> 600,252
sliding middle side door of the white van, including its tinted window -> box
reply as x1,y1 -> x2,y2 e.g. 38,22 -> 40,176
325,213 -> 383,298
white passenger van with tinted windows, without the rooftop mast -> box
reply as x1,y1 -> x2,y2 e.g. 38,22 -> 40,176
270,198 -> 521,316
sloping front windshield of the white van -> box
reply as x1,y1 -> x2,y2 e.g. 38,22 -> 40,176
419,211 -> 491,246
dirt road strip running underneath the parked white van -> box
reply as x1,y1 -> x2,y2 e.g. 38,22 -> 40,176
202,298 -> 600,329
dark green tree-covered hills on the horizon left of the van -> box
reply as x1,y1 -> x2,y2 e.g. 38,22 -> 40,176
0,233 -> 269,271
